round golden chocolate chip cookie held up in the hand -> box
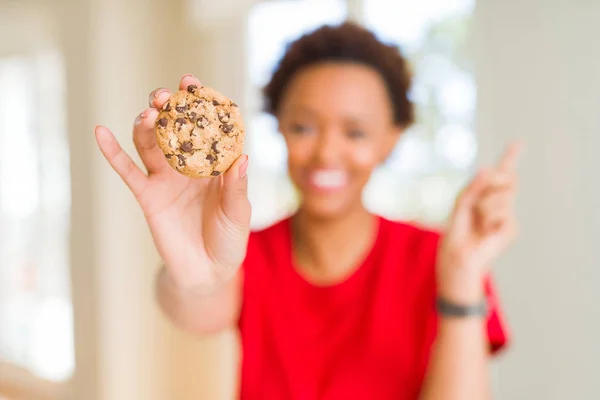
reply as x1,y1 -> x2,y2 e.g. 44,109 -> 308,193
156,85 -> 244,178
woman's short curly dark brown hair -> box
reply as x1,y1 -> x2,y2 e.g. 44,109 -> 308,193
264,22 -> 414,127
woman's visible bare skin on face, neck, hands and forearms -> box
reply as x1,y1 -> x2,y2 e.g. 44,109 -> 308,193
96,63 -> 521,400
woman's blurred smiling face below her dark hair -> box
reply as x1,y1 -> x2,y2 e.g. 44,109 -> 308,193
278,63 -> 401,218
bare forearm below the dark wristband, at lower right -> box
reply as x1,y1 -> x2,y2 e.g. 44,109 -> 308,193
420,317 -> 491,400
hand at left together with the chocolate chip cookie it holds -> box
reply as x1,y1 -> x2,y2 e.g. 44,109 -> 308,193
96,75 -> 250,288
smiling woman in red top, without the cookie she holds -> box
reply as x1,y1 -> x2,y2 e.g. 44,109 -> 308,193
96,23 -> 519,400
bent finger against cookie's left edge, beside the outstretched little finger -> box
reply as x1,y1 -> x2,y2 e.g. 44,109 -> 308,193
133,108 -> 168,174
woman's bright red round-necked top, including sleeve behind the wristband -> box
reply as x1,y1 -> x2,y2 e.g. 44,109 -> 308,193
239,218 -> 507,400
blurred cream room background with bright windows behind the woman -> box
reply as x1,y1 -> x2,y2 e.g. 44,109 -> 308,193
0,0 -> 600,400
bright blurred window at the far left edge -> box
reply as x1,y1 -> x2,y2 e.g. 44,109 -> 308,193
0,52 -> 74,381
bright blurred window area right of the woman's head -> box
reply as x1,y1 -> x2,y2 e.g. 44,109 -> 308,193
363,0 -> 477,224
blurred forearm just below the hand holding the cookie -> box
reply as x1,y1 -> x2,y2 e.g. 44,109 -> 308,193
156,267 -> 241,334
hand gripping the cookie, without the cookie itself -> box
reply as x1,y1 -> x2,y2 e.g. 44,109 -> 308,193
95,75 -> 250,288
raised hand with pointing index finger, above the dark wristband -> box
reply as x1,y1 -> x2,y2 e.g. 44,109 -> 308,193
437,143 -> 523,301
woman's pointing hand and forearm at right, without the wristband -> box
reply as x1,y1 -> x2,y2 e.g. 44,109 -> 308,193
420,143 -> 523,400
